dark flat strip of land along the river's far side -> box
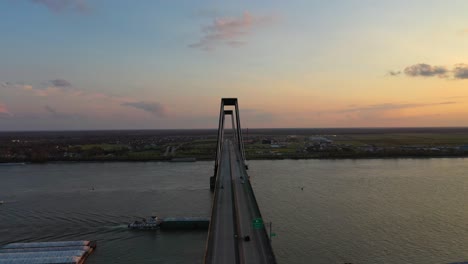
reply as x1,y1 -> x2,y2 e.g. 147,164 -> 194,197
0,128 -> 468,163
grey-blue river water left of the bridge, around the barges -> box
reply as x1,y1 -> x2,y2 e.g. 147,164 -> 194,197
0,162 -> 212,264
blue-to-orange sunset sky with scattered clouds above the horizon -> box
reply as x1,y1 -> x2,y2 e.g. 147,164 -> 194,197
0,0 -> 468,131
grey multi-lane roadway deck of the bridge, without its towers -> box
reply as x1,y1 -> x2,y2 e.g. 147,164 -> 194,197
205,141 -> 276,263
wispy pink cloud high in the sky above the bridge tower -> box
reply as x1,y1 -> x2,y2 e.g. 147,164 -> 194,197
189,12 -> 275,50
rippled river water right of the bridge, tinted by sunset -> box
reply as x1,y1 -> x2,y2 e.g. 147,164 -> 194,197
250,159 -> 468,263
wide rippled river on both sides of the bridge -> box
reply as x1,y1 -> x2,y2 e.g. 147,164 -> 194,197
0,158 -> 468,264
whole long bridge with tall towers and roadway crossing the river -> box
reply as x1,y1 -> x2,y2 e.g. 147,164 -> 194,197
204,98 -> 276,264
